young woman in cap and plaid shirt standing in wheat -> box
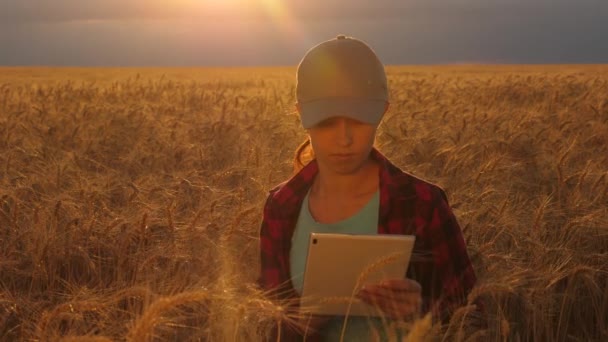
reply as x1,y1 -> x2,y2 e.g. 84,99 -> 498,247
260,36 -> 476,341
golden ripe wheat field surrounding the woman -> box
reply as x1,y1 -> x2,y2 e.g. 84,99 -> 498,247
0,65 -> 608,341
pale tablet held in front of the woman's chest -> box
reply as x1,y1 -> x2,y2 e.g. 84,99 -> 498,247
300,233 -> 415,316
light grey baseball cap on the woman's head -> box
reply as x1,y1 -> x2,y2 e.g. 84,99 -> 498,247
296,35 -> 388,128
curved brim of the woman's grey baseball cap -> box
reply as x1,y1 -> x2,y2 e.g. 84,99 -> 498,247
300,99 -> 386,128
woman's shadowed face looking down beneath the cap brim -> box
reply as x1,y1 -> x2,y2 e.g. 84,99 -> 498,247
307,116 -> 377,174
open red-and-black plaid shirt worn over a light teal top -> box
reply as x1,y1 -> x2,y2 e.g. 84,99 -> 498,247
259,149 -> 476,340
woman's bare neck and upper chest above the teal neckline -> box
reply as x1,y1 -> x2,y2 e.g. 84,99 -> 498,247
311,159 -> 379,198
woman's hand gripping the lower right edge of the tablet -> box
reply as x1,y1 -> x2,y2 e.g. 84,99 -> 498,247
357,279 -> 422,320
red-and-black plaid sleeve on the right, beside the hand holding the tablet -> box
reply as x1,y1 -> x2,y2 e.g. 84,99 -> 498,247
427,188 -> 476,321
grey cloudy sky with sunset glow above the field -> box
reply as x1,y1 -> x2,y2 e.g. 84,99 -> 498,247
0,0 -> 608,66
